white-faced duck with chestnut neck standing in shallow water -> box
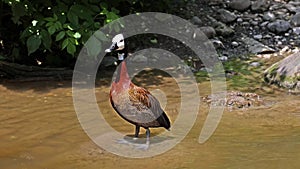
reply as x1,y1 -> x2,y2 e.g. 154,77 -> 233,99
105,34 -> 171,149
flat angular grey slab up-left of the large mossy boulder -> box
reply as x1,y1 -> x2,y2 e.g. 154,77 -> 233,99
241,34 -> 275,54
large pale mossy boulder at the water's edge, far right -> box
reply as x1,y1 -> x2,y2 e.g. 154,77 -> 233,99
264,52 -> 300,89
